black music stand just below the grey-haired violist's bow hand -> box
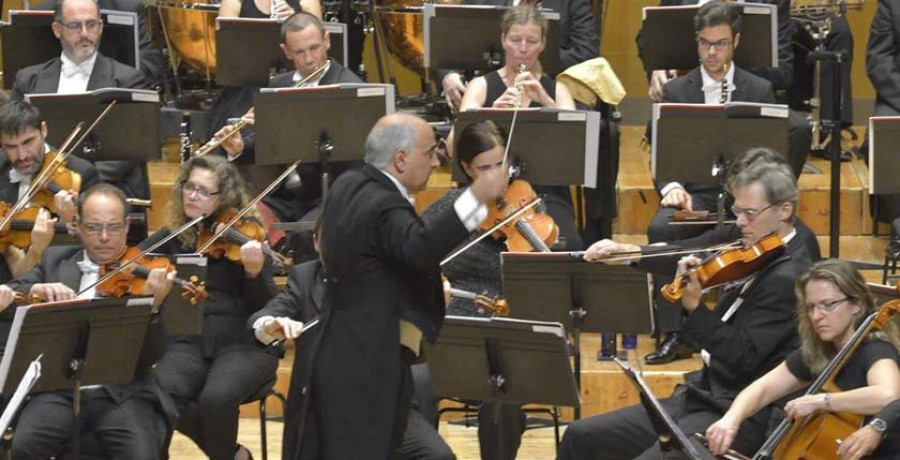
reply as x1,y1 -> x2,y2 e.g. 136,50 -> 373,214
500,252 -> 653,418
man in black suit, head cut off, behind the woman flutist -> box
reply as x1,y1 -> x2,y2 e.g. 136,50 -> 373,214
436,0 -> 603,110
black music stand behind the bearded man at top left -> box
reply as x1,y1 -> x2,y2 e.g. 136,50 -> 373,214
0,10 -> 141,88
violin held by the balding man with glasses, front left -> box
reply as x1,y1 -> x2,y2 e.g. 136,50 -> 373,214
97,247 -> 208,305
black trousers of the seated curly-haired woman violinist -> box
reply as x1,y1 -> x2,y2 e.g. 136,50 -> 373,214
156,344 -> 278,460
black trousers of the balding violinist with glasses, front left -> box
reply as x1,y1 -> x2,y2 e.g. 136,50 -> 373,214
13,388 -> 168,460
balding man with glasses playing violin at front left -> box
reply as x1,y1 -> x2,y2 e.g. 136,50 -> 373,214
0,184 -> 174,459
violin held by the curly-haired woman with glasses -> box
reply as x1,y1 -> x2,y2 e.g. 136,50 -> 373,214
197,209 -> 290,266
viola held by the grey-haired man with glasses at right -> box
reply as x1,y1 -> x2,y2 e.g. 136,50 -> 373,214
662,233 -> 785,302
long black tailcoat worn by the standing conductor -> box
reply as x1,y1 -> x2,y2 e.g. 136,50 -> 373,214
284,165 -> 468,459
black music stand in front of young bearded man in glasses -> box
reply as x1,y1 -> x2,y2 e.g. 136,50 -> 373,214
650,102 -> 788,184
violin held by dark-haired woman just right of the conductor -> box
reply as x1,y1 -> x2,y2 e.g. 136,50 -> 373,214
481,179 -> 559,252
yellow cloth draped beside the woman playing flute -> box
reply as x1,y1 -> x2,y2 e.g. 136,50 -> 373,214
556,58 -> 625,107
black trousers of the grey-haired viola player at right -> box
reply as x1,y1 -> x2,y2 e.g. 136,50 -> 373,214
556,386 -> 768,460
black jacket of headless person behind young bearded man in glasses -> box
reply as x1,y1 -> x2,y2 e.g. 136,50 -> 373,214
636,0 -> 794,90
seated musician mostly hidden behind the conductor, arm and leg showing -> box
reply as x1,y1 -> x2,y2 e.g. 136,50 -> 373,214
247,219 -> 456,460
